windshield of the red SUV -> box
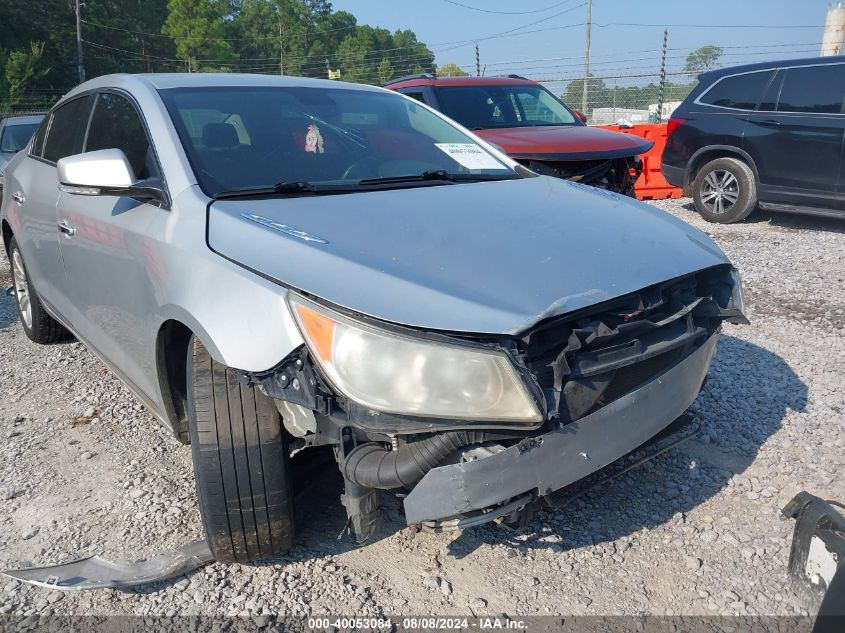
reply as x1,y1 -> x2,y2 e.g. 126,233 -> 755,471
436,84 -> 578,130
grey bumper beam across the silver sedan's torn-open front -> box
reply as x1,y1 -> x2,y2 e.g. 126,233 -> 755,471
404,334 -> 718,524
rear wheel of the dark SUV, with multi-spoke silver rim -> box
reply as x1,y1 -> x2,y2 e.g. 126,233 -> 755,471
692,158 -> 757,224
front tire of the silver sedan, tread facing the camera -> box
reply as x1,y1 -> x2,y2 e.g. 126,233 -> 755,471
187,337 -> 294,563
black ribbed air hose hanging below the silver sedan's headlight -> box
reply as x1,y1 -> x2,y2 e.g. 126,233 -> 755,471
341,431 -> 513,489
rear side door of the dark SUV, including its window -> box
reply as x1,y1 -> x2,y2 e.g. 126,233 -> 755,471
743,64 -> 845,208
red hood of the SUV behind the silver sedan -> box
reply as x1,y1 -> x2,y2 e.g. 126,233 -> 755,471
474,125 -> 654,160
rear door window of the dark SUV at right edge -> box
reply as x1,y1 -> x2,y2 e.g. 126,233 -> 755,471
777,64 -> 845,114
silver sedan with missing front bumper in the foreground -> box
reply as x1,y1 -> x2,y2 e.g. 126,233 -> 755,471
0,74 -> 745,561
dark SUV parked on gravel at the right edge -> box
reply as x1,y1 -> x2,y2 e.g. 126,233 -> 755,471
661,57 -> 845,223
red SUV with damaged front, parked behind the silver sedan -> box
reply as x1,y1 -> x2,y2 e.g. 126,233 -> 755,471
385,74 -> 653,196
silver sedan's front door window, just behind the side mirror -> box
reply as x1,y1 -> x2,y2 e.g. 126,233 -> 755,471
85,92 -> 159,180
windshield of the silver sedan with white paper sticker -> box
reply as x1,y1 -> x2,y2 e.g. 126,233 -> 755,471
160,86 -> 519,196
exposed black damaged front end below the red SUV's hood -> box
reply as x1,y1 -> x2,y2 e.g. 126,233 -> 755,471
515,156 -> 643,197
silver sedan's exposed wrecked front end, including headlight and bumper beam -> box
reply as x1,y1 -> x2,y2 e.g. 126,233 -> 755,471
241,264 -> 747,542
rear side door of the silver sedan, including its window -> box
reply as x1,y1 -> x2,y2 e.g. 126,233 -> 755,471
6,95 -> 91,314
